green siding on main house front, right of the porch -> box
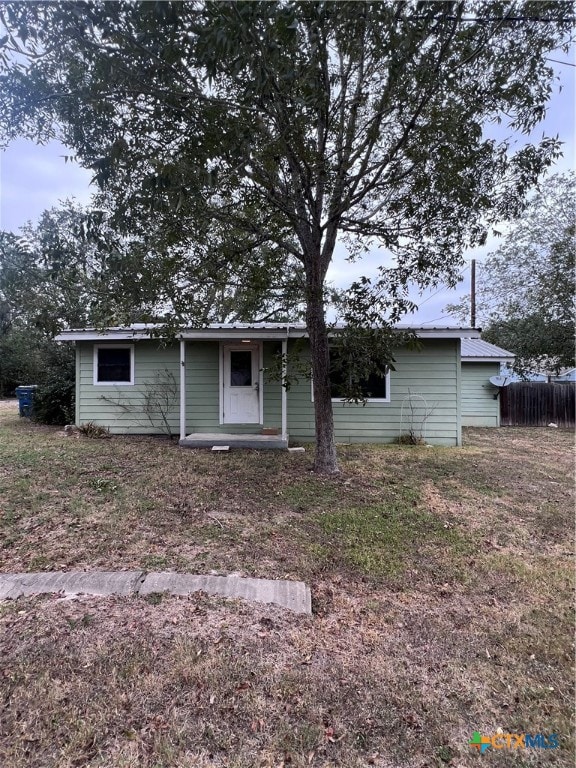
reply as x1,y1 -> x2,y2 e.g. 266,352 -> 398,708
288,339 -> 461,445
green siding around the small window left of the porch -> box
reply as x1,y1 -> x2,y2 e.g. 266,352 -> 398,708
76,341 -> 180,435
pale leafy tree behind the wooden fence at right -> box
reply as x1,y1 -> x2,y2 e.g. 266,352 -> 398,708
449,172 -> 576,374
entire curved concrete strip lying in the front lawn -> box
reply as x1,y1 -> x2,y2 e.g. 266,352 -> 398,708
0,571 -> 312,614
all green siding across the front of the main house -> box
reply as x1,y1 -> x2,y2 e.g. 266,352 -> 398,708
77,339 -> 461,445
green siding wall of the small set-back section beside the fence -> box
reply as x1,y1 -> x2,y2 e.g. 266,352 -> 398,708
462,362 -> 500,427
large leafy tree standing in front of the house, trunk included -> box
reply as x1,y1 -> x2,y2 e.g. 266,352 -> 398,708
0,2 -> 573,472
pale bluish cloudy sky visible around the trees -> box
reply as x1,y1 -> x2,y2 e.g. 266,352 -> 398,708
0,52 -> 576,326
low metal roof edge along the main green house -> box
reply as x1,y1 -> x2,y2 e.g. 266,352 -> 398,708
56,323 -> 480,341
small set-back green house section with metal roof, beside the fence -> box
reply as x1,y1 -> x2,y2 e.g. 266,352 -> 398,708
461,338 -> 514,427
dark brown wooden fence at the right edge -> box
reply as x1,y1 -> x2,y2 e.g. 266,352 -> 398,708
500,381 -> 576,427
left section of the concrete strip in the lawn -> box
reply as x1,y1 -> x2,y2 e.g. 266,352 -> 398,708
0,571 -> 144,600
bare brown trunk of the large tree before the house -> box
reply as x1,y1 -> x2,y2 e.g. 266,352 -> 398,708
306,276 -> 338,474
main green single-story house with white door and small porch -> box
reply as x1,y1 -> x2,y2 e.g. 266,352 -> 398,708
58,323 -> 479,448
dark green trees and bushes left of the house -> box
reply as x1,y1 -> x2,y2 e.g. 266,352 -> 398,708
0,201 -> 109,402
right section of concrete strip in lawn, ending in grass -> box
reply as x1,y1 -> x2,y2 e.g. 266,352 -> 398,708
139,572 -> 312,614
